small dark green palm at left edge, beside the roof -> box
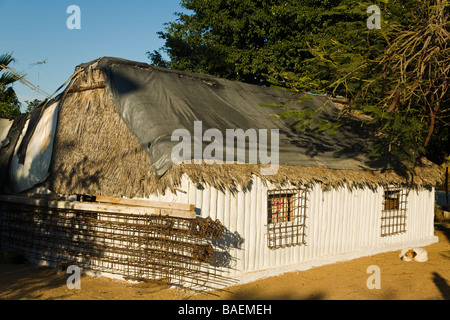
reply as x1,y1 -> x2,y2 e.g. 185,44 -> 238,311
0,54 -> 20,116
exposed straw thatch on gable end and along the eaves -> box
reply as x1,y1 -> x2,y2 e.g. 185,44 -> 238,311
44,58 -> 440,198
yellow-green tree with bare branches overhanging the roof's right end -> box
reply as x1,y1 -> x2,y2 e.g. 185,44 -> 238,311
281,0 -> 450,163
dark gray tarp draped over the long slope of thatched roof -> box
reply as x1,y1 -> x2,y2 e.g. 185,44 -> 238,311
79,57 -> 370,176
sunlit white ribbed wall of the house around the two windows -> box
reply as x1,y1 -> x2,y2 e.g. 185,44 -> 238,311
145,177 -> 437,284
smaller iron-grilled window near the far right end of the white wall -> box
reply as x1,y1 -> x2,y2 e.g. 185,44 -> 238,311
381,188 -> 407,237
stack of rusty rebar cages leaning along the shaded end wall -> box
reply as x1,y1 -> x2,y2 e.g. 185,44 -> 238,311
0,202 -> 224,287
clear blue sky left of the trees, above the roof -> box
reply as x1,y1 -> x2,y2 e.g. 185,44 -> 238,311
0,0 -> 186,110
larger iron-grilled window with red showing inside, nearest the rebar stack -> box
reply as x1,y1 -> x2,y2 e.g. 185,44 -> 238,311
267,189 -> 308,249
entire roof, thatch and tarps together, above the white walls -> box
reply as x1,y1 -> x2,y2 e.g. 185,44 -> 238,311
0,58 -> 440,197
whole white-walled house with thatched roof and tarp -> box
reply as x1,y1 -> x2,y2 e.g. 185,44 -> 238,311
0,57 -> 439,287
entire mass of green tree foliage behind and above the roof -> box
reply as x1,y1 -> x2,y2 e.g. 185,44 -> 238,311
152,0 -> 450,165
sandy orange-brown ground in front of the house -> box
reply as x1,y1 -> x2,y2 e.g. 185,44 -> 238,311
0,222 -> 450,300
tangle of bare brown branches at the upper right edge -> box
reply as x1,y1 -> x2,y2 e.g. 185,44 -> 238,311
380,0 -> 450,154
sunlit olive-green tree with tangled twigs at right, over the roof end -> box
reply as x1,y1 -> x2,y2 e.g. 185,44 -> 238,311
315,0 -> 450,162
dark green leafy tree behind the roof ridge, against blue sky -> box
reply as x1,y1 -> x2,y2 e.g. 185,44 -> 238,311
148,0 -> 360,84
